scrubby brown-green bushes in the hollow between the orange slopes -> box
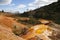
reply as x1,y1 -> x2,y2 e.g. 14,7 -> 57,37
13,26 -> 28,36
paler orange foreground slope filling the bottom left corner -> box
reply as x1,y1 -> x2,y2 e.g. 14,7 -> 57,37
0,25 -> 24,40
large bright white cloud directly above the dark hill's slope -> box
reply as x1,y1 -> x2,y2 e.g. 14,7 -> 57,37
28,0 -> 58,9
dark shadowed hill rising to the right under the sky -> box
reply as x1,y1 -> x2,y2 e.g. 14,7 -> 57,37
21,0 -> 60,24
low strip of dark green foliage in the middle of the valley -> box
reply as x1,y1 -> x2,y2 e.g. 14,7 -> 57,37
17,18 -> 40,25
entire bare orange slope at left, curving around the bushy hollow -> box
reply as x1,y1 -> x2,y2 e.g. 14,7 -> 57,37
0,15 -> 26,40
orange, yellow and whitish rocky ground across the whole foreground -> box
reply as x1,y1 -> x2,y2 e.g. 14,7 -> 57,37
0,16 -> 60,40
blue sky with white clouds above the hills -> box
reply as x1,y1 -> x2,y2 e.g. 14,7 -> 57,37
0,0 -> 57,12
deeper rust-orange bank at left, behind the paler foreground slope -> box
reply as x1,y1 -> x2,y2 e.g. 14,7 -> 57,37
0,16 -> 26,28
